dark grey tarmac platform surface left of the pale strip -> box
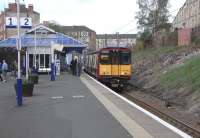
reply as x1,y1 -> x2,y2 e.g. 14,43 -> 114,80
0,74 -> 132,138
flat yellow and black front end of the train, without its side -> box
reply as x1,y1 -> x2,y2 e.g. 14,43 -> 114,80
99,48 -> 131,87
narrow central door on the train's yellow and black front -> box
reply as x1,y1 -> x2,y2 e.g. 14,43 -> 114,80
110,50 -> 120,76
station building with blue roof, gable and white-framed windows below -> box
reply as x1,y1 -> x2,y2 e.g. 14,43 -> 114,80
0,24 -> 86,72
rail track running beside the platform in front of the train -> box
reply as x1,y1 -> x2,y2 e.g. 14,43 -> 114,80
120,84 -> 200,138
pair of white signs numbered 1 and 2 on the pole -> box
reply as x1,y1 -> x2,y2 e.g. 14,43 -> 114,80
6,17 -> 32,28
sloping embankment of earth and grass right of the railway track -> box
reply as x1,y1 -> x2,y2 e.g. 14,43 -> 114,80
130,47 -> 200,118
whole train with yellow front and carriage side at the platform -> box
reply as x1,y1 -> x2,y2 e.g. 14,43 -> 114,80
85,47 -> 132,89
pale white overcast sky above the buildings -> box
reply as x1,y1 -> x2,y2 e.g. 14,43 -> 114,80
0,0 -> 185,34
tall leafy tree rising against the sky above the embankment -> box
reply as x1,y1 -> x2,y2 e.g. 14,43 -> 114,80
136,0 -> 169,33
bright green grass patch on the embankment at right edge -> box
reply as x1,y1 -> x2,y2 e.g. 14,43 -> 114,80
160,56 -> 200,90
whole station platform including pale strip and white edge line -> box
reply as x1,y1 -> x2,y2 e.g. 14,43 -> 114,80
0,73 -> 189,138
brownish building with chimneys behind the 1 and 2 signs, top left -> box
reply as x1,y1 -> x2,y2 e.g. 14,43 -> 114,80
0,3 -> 40,40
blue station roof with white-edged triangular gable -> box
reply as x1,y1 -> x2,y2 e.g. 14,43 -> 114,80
0,25 -> 86,53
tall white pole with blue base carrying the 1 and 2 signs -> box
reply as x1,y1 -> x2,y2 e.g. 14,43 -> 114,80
16,0 -> 22,106
